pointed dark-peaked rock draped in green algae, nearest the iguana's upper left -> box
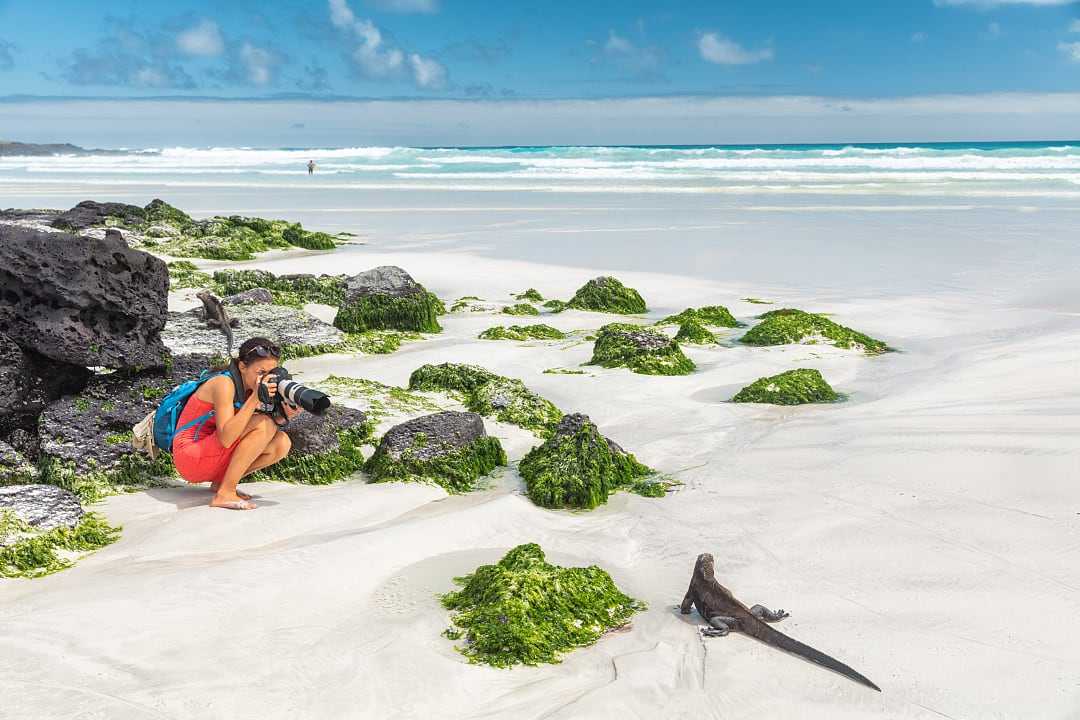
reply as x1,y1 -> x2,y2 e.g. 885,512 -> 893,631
518,413 -> 664,510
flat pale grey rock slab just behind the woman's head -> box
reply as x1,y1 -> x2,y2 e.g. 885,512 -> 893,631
162,304 -> 345,356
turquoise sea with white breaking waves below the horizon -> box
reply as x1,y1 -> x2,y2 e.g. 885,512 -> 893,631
0,140 -> 1080,198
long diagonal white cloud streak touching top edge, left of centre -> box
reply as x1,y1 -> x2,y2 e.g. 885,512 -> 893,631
328,0 -> 447,90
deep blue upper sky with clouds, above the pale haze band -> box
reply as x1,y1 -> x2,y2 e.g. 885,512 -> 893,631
0,0 -> 1080,98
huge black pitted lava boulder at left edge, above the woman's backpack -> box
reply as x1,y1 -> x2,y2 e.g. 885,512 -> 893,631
0,225 -> 168,368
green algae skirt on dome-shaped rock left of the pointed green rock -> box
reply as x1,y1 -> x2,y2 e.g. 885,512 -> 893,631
364,433 -> 507,493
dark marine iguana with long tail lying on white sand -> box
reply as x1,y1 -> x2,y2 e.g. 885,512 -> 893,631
679,553 -> 881,692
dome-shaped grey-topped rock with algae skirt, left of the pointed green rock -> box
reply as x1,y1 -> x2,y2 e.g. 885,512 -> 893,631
364,411 -> 507,492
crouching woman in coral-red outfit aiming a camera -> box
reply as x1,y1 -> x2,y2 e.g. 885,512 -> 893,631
173,338 -> 301,510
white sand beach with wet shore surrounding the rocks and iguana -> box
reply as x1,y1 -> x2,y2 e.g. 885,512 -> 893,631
0,174 -> 1080,720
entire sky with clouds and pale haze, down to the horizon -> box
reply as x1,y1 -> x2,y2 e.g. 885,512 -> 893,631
0,0 -> 1080,147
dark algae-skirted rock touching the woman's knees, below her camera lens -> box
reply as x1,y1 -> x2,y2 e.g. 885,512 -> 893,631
250,405 -> 372,485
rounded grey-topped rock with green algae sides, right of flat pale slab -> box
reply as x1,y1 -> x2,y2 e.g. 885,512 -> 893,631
334,266 -> 446,332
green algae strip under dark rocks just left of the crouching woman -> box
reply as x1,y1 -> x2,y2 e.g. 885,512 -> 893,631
38,452 -> 177,505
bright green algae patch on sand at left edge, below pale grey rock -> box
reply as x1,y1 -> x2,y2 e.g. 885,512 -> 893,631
0,508 -> 121,578
